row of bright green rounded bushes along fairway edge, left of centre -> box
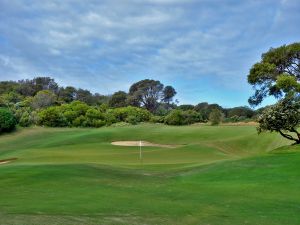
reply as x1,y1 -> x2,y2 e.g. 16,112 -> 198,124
38,101 -> 152,127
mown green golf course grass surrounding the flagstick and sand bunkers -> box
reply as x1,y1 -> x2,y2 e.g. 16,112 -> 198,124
0,124 -> 300,225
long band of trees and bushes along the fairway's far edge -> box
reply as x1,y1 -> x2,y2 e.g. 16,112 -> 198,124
0,77 -> 257,131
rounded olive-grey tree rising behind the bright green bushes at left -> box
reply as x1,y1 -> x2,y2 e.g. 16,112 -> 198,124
31,90 -> 57,109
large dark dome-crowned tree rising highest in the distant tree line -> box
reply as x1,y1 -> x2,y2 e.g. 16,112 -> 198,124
129,79 -> 164,113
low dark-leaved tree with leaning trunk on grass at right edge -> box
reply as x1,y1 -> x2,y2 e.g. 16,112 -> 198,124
257,96 -> 300,144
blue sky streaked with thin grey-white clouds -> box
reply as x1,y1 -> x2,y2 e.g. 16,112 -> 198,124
0,0 -> 300,107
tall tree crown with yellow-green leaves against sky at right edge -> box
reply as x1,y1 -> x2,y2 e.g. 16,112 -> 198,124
248,43 -> 300,106
